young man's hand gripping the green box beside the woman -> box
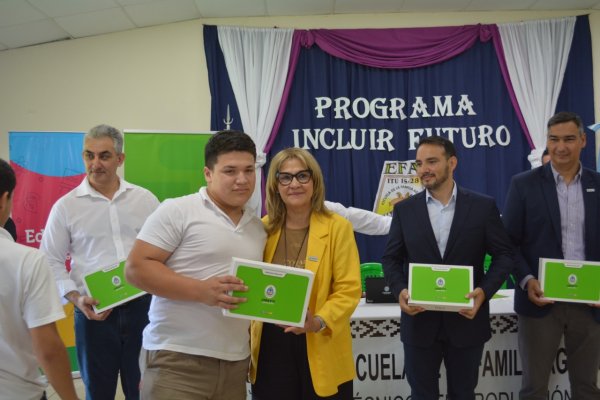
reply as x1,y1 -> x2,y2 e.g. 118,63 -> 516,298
199,275 -> 248,310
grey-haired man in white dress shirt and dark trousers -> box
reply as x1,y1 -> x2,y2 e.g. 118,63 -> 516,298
40,125 -> 159,400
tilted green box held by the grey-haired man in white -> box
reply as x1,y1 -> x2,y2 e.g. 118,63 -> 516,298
83,261 -> 146,313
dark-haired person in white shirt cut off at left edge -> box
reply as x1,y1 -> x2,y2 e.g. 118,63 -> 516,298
0,159 -> 77,400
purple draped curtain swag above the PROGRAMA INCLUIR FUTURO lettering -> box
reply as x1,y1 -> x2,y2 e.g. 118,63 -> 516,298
264,24 -> 533,153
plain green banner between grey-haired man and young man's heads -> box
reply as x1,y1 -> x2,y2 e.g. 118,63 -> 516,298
123,129 -> 211,202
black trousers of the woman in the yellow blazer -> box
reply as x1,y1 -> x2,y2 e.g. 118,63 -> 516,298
252,323 -> 353,400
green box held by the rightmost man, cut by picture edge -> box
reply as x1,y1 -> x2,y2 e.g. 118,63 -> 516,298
539,258 -> 600,304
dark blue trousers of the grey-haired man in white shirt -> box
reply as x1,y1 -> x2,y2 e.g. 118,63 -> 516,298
75,295 -> 152,400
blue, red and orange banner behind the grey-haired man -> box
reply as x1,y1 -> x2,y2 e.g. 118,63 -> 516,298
8,132 -> 85,371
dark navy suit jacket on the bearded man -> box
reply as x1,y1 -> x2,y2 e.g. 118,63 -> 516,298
382,187 -> 513,347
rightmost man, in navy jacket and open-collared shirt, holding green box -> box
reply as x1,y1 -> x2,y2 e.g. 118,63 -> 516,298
504,112 -> 600,400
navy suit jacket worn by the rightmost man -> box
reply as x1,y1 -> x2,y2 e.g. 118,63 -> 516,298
503,163 -> 600,322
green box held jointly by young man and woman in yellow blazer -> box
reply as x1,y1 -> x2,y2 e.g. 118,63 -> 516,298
223,257 -> 314,327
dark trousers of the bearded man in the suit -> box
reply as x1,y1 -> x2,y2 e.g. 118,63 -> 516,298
404,340 -> 483,400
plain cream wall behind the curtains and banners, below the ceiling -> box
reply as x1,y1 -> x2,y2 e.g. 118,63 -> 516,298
0,11 -> 600,159
